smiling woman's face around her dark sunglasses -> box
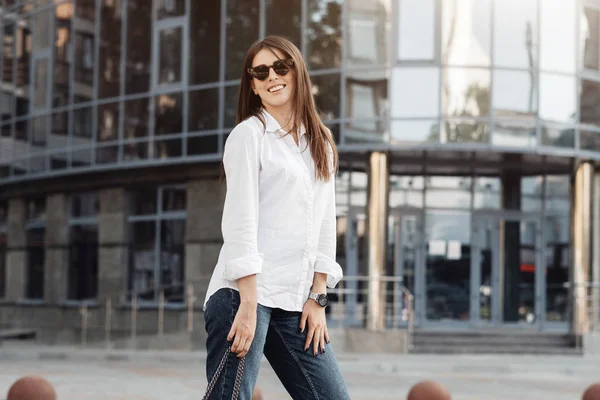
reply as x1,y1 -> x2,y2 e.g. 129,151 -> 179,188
251,49 -> 296,113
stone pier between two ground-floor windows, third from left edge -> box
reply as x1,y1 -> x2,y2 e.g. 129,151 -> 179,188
98,188 -> 128,305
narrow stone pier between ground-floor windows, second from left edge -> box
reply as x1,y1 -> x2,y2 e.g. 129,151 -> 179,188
44,193 -> 69,304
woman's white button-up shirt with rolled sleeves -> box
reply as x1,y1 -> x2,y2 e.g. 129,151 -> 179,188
204,111 -> 342,311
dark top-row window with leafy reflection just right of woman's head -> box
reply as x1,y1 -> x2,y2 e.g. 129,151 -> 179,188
306,0 -> 342,70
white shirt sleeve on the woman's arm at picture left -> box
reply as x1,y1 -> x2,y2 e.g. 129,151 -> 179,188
221,125 -> 263,281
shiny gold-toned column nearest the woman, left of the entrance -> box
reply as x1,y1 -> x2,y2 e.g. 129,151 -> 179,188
367,152 -> 389,331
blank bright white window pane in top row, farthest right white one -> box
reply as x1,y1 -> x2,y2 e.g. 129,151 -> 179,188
540,0 -> 577,73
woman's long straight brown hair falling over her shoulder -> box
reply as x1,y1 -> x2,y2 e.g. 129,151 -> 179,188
236,36 -> 338,181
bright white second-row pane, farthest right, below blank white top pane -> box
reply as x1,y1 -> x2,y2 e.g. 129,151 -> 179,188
539,73 -> 577,123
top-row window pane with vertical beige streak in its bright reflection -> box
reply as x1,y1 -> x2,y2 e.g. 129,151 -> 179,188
442,0 -> 492,66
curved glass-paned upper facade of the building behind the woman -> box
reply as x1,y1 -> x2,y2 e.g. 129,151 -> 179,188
0,0 -> 600,183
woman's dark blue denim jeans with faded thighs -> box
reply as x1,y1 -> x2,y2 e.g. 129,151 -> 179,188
204,289 -> 350,400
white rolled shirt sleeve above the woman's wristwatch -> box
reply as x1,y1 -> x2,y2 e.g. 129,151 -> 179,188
315,164 -> 344,288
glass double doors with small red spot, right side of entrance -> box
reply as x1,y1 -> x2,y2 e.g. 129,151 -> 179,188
471,215 -> 544,328
